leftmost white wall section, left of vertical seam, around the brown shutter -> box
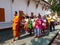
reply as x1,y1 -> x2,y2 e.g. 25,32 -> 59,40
0,0 -> 11,22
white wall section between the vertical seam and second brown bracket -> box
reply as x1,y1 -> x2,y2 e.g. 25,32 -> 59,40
12,0 -> 27,14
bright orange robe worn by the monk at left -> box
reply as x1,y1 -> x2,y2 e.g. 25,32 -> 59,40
12,16 -> 20,37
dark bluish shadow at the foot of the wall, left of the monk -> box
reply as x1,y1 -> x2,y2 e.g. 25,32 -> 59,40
0,30 -> 13,43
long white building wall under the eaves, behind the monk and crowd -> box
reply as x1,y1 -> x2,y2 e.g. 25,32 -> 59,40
0,0 -> 45,22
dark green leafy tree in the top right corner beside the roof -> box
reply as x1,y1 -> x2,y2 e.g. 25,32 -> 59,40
48,0 -> 60,15
